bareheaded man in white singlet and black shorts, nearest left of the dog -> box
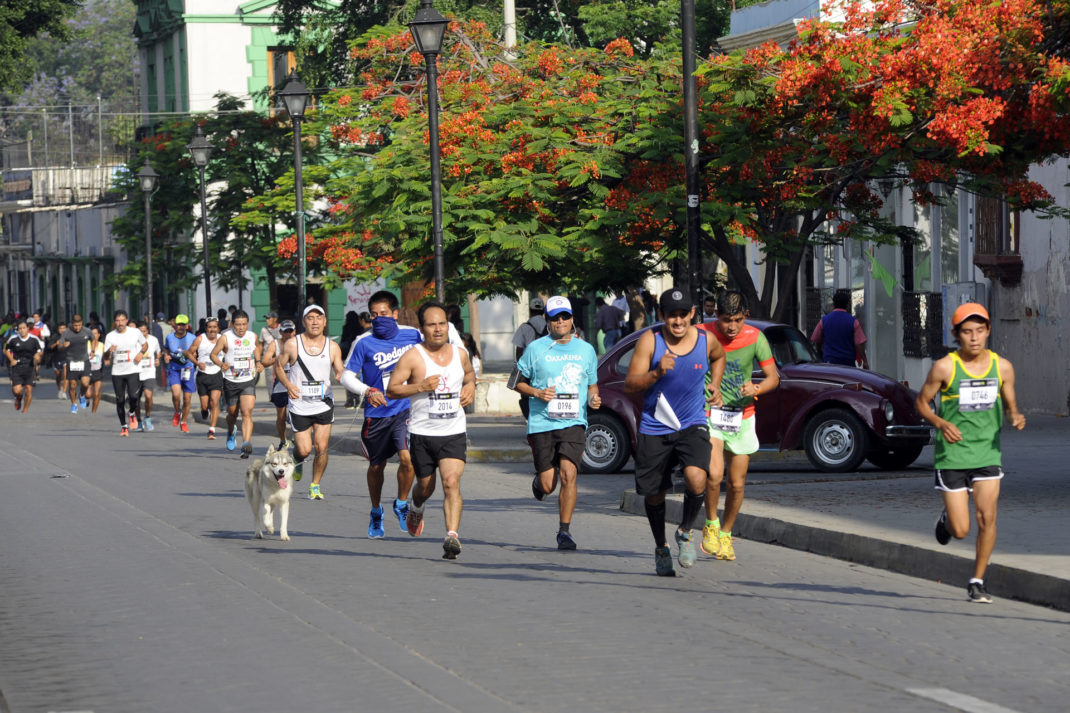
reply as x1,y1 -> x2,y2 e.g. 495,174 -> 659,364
212,309 -> 263,458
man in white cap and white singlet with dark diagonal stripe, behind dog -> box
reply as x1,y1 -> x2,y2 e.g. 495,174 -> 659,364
275,304 -> 343,500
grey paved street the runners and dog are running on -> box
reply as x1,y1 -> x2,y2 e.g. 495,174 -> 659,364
0,385 -> 1070,713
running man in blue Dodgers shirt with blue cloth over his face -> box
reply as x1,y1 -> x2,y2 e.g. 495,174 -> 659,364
342,290 -> 421,538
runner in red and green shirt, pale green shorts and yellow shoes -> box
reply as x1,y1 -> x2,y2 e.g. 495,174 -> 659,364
699,291 -> 780,560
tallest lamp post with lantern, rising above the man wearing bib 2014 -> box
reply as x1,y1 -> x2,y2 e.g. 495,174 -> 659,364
409,0 -> 449,302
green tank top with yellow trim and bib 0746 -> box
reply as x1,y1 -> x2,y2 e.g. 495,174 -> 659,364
933,351 -> 1003,470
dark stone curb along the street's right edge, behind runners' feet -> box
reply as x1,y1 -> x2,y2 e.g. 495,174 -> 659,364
621,490 -> 1070,611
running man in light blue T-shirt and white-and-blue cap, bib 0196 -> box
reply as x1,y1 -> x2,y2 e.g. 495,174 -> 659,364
517,295 -> 601,549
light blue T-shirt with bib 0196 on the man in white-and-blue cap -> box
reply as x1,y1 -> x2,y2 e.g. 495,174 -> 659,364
517,335 -> 598,434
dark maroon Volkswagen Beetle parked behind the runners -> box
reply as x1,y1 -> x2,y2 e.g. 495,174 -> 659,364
583,320 -> 932,473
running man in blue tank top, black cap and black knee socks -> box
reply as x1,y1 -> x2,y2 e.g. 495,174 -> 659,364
624,287 -> 724,577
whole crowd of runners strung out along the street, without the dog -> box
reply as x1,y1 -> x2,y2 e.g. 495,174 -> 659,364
4,288 -> 1025,602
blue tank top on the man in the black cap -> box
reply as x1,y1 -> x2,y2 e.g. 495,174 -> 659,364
639,330 -> 709,436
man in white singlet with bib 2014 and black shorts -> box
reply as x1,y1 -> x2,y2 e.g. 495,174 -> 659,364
386,302 -> 475,560
